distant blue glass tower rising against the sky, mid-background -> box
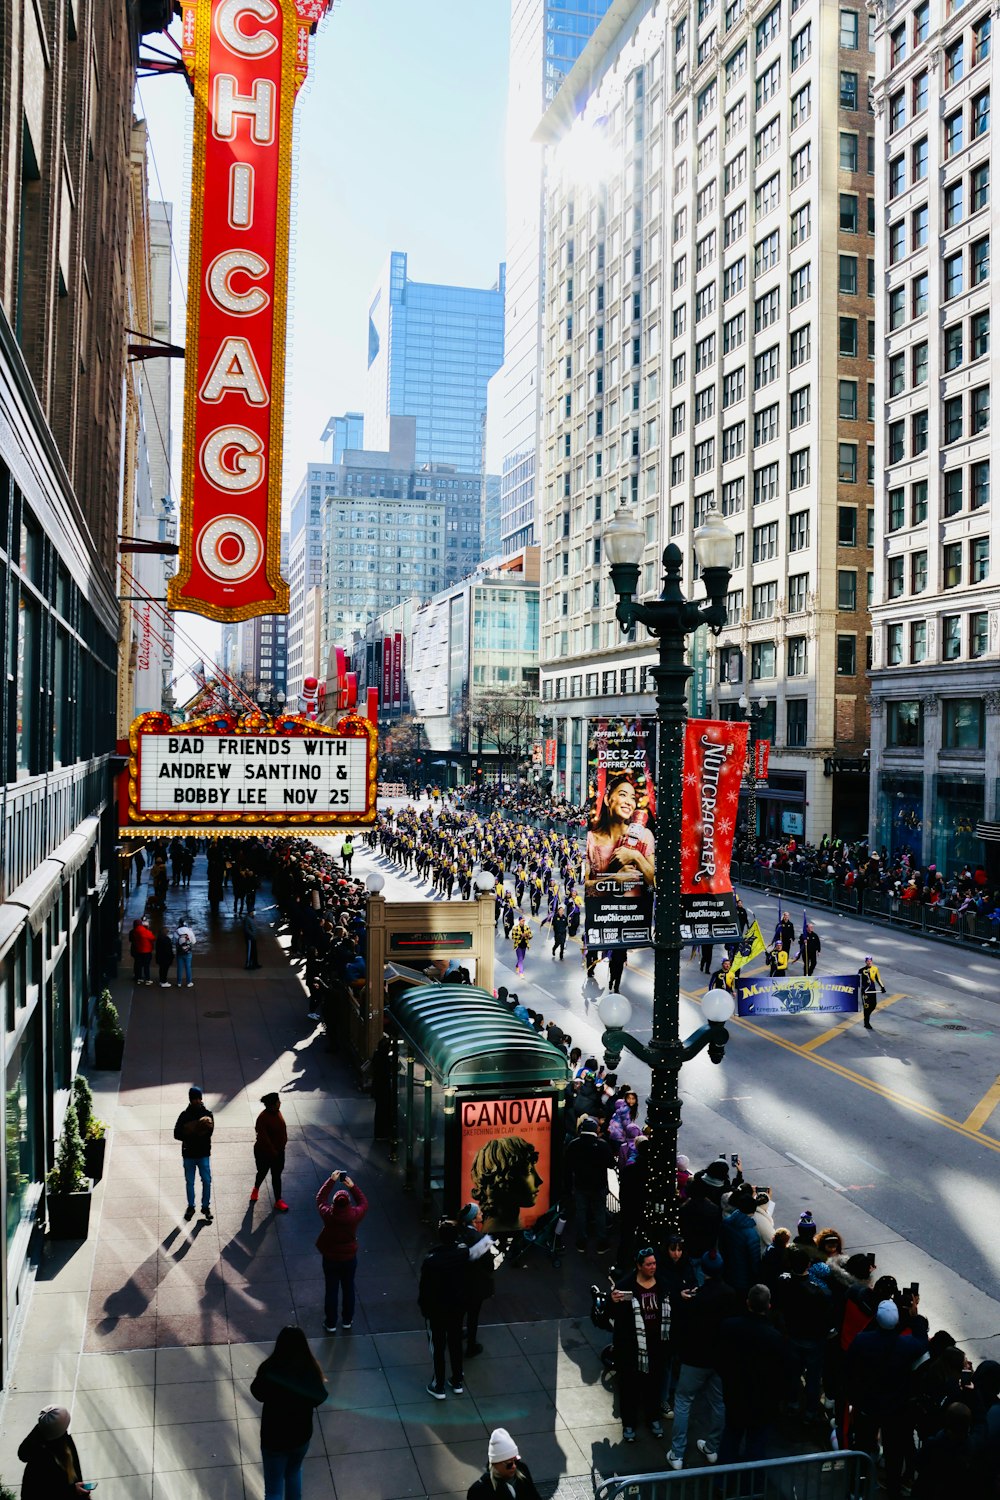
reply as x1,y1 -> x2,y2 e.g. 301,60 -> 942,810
364,251 -> 504,474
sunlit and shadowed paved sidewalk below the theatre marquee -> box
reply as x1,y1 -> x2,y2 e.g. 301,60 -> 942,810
0,857 -> 666,1500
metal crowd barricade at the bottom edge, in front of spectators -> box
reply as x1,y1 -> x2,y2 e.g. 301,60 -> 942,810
595,1452 -> 877,1500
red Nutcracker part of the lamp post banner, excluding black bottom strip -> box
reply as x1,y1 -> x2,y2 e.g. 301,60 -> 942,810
681,719 -> 748,896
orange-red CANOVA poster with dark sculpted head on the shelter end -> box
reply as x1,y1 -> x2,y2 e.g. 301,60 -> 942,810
459,1095 -> 555,1235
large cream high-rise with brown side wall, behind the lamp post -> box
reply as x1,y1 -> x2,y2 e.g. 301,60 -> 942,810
541,0 -> 874,837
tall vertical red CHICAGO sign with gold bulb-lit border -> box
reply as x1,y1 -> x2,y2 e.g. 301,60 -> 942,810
169,0 -> 330,621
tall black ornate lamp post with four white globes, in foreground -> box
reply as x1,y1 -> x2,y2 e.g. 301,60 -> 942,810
598,506 -> 736,1245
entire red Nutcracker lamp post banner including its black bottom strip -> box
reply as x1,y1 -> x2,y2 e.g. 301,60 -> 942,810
681,719 -> 748,944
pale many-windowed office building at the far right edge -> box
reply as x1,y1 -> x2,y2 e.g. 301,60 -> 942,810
871,0 -> 1000,873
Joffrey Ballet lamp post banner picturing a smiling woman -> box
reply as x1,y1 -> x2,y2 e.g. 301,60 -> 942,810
583,719 -> 657,948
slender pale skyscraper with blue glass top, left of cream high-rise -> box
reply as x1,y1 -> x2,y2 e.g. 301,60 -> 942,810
497,0 -> 610,555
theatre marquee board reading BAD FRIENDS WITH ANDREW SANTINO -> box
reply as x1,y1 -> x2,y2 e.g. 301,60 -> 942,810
121,714 -> 376,836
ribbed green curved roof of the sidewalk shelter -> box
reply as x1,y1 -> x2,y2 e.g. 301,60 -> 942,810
390,984 -> 570,1088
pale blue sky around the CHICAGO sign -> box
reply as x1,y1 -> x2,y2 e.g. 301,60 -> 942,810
136,0 -> 510,681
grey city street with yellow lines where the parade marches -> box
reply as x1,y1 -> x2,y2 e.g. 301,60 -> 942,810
355,804 -> 1000,1359
